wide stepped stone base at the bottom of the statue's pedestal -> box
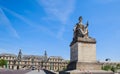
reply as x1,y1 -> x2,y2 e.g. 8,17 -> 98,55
59,61 -> 114,74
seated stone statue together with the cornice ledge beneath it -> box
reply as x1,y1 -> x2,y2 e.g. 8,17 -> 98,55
70,16 -> 96,46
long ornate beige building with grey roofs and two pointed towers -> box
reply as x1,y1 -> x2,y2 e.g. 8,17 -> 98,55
0,50 -> 69,71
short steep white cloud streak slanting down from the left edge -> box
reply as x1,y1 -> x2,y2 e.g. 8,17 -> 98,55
0,8 -> 19,38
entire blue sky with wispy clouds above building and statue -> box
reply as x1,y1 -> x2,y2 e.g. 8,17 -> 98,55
0,0 -> 120,61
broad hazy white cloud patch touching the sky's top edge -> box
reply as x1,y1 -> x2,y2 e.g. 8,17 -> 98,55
37,0 -> 75,24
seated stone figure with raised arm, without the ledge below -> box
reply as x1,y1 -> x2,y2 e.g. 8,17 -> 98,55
73,16 -> 88,38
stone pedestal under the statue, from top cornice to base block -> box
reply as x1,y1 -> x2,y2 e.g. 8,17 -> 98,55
68,37 -> 101,70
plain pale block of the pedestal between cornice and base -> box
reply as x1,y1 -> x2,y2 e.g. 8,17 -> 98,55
70,42 -> 96,62
